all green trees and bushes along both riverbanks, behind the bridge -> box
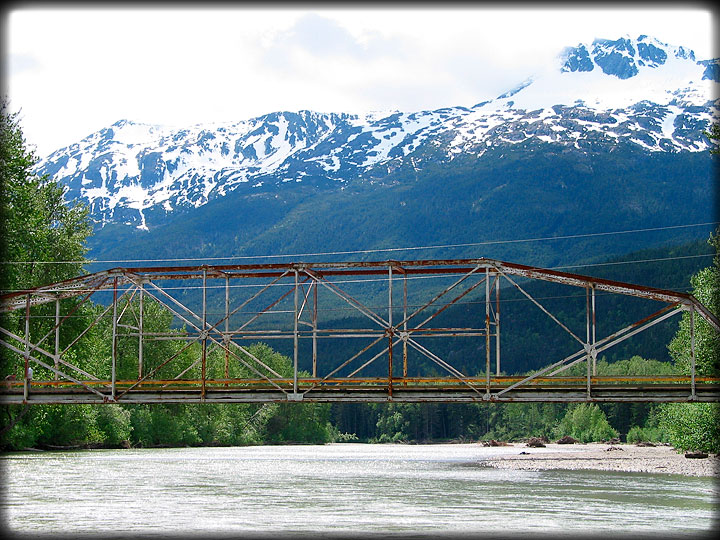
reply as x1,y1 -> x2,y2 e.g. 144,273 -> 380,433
0,104 -> 720,452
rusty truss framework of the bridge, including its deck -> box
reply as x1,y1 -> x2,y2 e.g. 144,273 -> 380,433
0,258 -> 720,403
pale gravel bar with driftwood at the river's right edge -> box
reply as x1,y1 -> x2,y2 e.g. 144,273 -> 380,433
483,443 -> 720,478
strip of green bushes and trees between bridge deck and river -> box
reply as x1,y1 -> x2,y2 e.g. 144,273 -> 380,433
2,384 -> 716,452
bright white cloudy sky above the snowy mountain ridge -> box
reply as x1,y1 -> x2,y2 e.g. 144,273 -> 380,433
2,3 -> 718,157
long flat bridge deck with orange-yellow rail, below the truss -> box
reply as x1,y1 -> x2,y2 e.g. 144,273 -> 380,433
0,376 -> 720,404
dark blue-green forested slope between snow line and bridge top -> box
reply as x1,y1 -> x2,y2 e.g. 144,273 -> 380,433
84,142 -> 715,270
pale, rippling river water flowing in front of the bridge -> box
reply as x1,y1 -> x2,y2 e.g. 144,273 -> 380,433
1,444 -> 720,537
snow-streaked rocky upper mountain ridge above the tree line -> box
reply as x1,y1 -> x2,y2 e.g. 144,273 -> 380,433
37,36 -> 720,229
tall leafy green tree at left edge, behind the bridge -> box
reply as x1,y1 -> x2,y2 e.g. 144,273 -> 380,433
0,100 -> 97,448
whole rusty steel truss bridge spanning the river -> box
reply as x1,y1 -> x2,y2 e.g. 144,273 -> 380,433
0,258 -> 720,404
